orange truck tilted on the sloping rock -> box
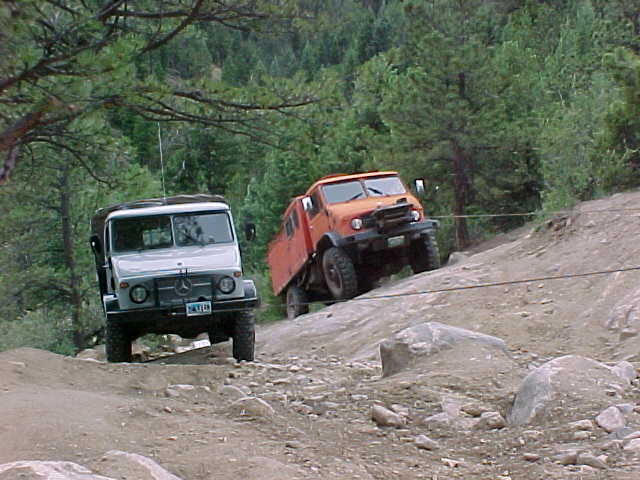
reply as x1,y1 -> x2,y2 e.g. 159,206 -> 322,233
267,171 -> 440,318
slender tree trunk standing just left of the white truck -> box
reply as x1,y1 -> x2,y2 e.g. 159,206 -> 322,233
60,168 -> 85,351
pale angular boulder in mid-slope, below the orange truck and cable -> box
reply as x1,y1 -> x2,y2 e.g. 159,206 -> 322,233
380,322 -> 508,377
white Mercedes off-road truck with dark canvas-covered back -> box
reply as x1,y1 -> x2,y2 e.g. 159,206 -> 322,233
90,194 -> 259,362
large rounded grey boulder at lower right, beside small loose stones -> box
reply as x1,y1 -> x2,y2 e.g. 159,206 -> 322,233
508,355 -> 628,425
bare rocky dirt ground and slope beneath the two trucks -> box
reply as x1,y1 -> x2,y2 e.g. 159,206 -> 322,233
0,192 -> 640,480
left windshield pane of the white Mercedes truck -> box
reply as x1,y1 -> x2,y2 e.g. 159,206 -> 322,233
112,215 -> 173,252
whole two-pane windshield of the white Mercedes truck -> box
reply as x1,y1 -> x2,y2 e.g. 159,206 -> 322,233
112,212 -> 233,252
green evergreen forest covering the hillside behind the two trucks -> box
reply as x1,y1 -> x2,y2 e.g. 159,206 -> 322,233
0,0 -> 640,354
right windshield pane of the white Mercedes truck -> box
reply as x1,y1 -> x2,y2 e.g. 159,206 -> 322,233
173,212 -> 233,247
